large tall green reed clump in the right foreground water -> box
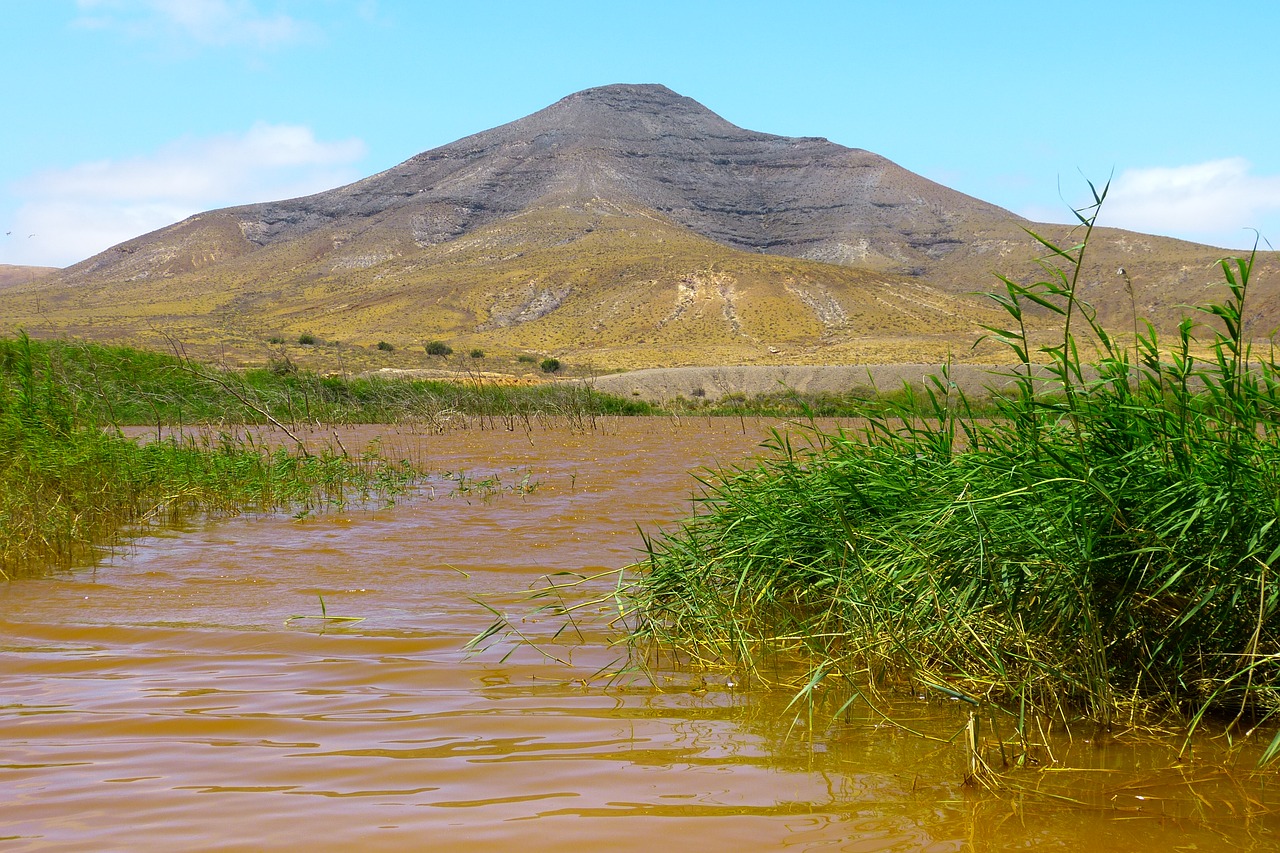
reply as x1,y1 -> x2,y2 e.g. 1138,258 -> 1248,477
632,190 -> 1280,725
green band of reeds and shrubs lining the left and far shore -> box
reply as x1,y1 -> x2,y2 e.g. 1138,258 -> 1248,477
0,325 -> 947,580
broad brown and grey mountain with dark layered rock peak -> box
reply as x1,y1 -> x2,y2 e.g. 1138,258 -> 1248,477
13,85 -> 1280,368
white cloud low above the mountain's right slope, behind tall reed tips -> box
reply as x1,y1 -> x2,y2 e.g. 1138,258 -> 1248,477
1023,158 -> 1280,250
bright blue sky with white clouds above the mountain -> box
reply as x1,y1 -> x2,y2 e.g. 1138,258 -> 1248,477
0,0 -> 1280,265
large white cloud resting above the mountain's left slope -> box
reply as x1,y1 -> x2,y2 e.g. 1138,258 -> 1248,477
0,124 -> 365,266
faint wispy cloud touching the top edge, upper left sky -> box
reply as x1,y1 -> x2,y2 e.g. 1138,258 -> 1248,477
76,0 -> 311,47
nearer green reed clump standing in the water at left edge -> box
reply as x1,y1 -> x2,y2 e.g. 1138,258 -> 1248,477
0,327 -> 413,578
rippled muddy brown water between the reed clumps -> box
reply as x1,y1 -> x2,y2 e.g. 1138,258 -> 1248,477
0,419 -> 1280,853
